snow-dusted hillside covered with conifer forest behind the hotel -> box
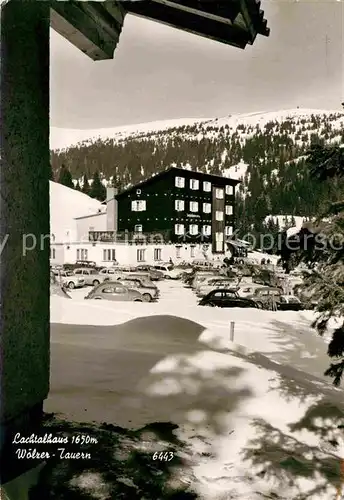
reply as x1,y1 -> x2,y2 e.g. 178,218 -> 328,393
51,114 -> 344,240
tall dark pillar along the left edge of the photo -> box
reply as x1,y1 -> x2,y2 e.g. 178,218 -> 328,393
0,0 -> 50,483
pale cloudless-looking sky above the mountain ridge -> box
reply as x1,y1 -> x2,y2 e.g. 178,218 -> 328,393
51,0 -> 344,129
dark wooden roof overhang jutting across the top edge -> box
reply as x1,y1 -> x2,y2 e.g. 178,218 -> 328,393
51,0 -> 270,61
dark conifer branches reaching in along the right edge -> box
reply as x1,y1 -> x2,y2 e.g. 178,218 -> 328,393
284,145 -> 344,386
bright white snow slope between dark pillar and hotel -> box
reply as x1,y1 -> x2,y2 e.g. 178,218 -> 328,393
50,181 -> 104,242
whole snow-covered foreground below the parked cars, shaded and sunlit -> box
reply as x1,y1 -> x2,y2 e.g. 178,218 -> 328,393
46,282 -> 344,500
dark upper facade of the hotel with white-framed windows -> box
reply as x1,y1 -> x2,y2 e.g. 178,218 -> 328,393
116,167 -> 239,253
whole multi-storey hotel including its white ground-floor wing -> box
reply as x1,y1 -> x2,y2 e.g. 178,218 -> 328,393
51,167 -> 240,266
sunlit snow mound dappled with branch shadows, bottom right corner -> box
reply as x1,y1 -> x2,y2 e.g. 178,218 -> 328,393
147,351 -> 344,500
